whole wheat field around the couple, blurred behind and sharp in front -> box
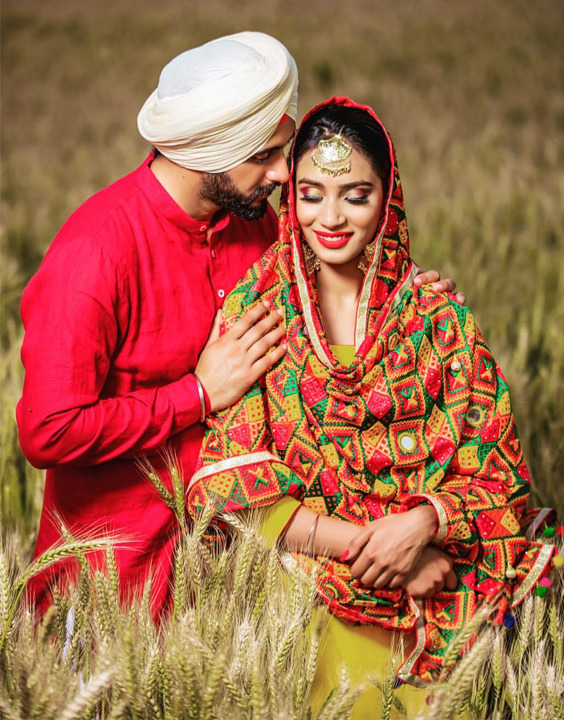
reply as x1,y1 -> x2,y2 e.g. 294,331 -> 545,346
0,0 -> 564,720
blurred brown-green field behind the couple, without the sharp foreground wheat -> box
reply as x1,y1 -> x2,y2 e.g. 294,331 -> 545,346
0,0 -> 564,536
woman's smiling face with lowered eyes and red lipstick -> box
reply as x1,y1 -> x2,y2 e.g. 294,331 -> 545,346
296,143 -> 383,266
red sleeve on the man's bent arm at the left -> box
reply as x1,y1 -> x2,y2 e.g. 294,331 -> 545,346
17,238 -> 200,467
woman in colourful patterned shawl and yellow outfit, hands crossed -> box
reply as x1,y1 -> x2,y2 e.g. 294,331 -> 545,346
188,98 -> 553,712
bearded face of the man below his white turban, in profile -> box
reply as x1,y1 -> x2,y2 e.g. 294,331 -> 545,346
200,118 -> 295,220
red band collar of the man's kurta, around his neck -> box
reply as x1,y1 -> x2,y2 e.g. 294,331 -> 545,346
137,152 -> 230,242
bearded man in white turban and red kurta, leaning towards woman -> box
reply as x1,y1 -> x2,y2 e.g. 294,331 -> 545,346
17,32 -> 458,610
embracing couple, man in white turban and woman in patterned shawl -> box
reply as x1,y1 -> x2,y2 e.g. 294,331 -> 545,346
18,33 -> 553,717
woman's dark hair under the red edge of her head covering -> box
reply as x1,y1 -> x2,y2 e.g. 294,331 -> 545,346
294,105 -> 390,197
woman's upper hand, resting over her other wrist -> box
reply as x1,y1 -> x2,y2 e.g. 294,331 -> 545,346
342,505 -> 437,589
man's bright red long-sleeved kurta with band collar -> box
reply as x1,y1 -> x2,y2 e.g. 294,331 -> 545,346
17,156 -> 277,606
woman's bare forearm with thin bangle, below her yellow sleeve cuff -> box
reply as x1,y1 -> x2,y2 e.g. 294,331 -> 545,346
283,507 -> 362,558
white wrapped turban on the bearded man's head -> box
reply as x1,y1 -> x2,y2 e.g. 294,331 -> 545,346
137,32 -> 298,173
